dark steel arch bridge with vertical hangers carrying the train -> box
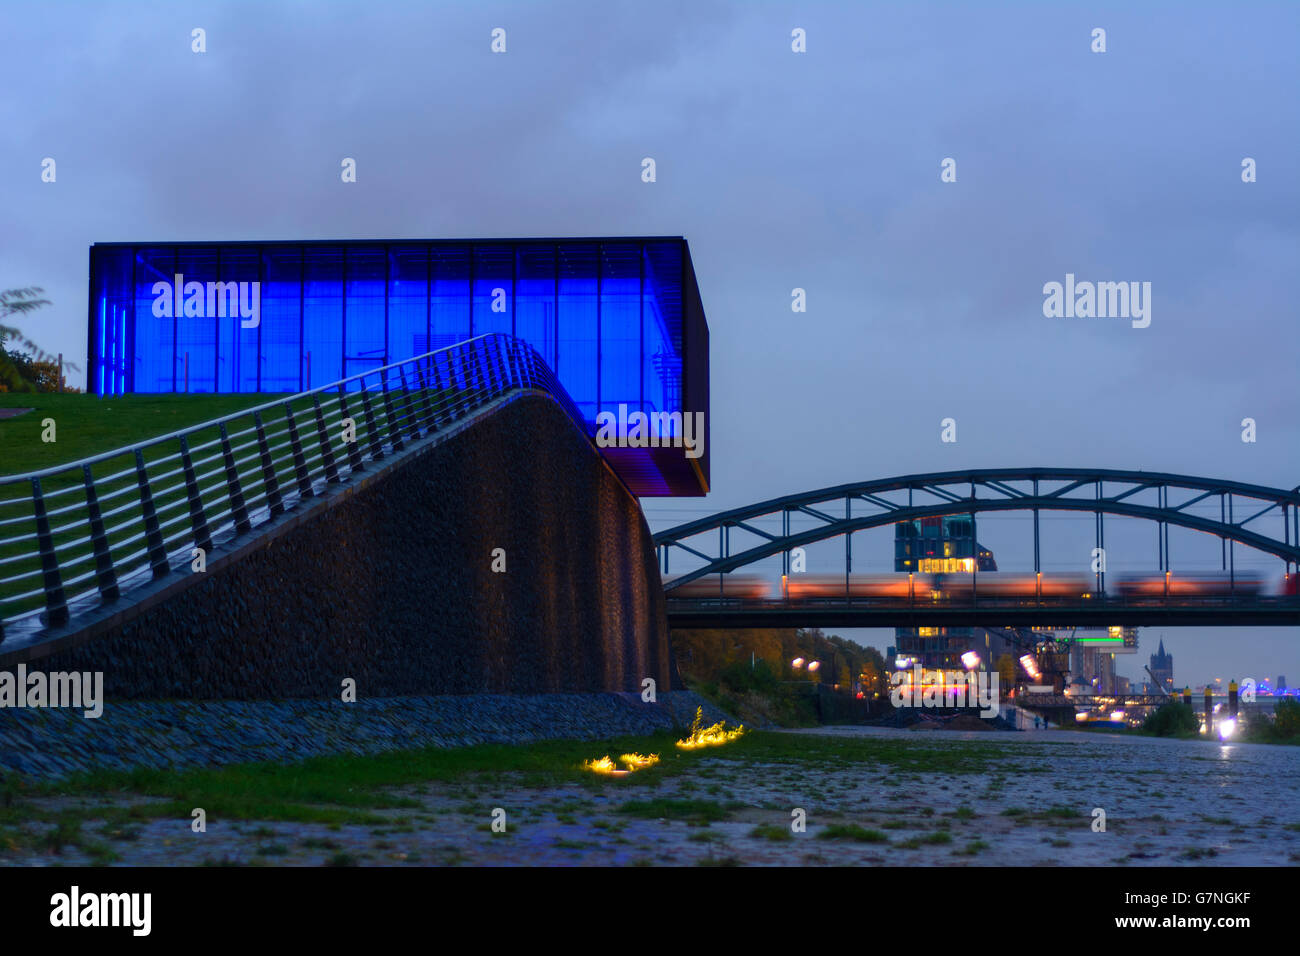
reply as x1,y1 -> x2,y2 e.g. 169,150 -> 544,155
654,468 -> 1300,627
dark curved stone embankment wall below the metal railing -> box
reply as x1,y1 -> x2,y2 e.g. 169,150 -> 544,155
10,393 -> 676,697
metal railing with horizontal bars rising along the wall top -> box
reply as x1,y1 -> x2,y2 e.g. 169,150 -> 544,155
0,333 -> 588,641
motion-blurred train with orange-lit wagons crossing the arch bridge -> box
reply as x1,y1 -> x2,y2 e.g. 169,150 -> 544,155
663,571 -> 1300,604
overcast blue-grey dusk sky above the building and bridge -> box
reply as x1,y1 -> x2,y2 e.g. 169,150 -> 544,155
0,0 -> 1300,683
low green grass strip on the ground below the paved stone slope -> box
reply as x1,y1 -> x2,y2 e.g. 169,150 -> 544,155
0,731 -> 1045,858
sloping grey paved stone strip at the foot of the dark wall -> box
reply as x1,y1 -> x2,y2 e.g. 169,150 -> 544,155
0,691 -> 731,779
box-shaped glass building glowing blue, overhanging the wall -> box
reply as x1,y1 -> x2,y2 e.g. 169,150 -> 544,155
88,237 -> 709,496
